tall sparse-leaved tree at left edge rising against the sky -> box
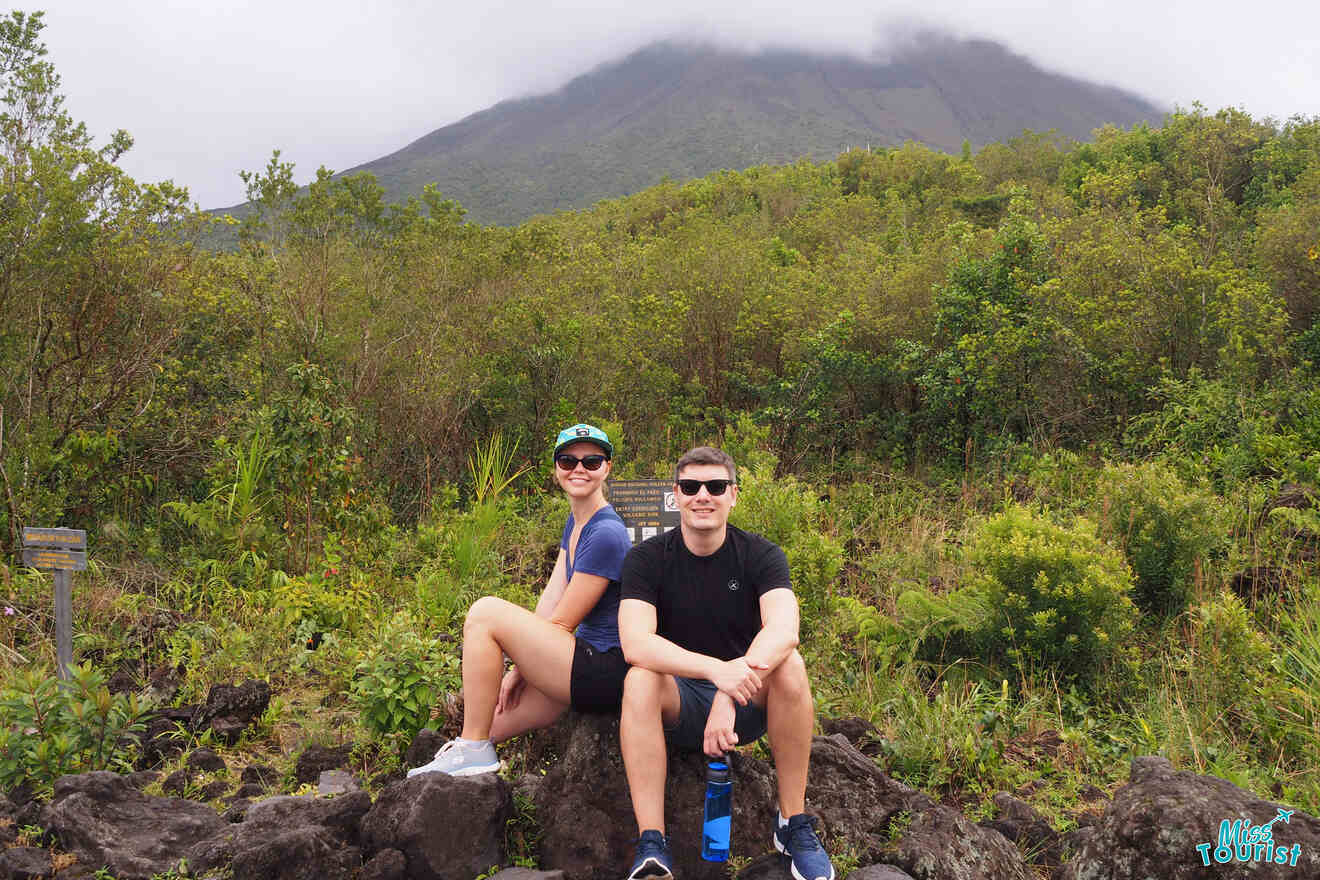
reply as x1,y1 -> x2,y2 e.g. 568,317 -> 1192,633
0,6 -> 189,550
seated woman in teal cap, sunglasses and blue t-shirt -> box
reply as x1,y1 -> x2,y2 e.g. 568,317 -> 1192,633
408,425 -> 632,776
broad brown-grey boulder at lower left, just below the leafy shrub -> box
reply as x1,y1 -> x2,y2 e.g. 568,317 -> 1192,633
41,770 -> 230,880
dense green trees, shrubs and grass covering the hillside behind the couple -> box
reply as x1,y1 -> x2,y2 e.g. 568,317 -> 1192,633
0,5 -> 1320,860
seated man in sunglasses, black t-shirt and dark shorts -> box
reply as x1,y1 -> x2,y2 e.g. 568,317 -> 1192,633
619,446 -> 834,880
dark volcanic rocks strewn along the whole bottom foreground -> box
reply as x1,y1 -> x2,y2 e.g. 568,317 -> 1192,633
0,701 -> 1320,880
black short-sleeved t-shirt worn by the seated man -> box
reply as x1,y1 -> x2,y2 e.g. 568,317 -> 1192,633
619,525 -> 792,660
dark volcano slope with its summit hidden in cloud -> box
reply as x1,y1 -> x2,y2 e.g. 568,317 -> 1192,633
281,36 -> 1163,223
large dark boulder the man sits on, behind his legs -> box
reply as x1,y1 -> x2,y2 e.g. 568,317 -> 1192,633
535,715 -> 776,880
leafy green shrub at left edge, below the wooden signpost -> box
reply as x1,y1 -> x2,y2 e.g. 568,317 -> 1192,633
0,665 -> 141,789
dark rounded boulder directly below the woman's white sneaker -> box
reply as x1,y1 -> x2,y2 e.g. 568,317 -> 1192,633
364,773 -> 513,880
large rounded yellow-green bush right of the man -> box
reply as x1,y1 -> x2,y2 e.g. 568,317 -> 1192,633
966,507 -> 1137,683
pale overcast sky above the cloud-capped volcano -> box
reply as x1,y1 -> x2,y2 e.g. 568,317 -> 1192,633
22,0 -> 1320,208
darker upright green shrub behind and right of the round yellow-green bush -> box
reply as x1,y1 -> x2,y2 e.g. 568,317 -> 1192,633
1097,462 -> 1224,617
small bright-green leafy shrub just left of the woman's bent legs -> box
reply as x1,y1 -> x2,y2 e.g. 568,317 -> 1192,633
348,613 -> 462,739
